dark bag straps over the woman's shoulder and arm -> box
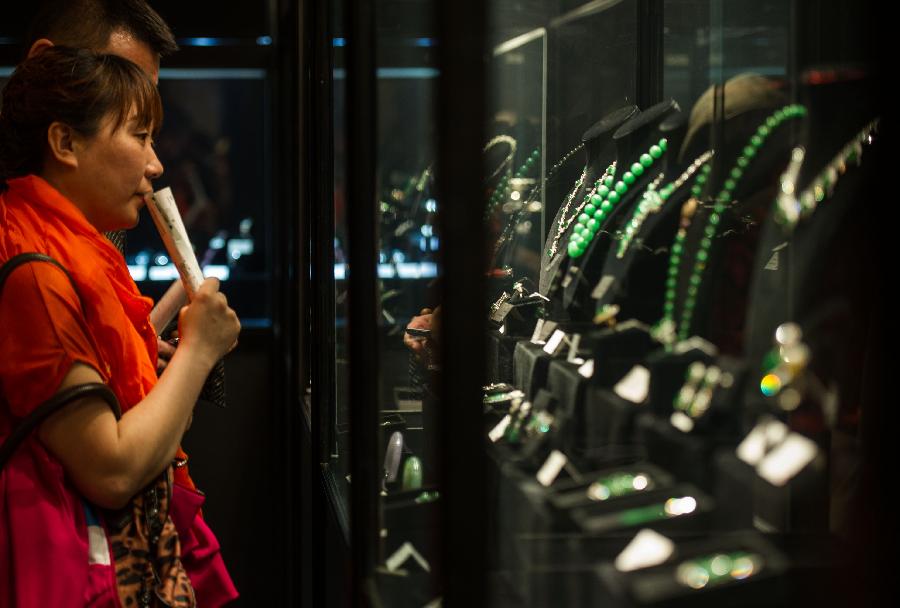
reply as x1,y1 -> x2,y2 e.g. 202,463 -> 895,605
0,253 -> 122,471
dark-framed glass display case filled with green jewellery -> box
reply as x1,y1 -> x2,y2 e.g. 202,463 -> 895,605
311,0 -> 884,607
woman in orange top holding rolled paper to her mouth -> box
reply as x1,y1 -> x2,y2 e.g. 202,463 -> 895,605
0,47 -> 240,608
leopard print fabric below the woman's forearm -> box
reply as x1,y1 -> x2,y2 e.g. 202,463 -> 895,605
106,467 -> 197,608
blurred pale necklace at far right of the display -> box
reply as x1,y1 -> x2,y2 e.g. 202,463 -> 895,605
775,119 -> 879,233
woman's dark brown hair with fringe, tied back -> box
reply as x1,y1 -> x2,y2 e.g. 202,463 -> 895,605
0,46 -> 162,187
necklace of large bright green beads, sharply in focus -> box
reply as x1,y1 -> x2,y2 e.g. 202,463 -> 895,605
568,138 -> 668,259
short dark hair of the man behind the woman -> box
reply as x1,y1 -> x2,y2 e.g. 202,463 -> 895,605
25,0 -> 178,57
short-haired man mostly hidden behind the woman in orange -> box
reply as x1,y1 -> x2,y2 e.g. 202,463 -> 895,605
26,0 -> 178,372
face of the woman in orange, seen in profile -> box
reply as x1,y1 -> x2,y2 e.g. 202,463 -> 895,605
70,108 -> 163,231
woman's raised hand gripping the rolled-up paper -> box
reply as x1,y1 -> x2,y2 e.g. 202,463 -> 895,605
178,278 -> 241,369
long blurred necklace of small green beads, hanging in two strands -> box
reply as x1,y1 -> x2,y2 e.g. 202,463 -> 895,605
654,104 -> 806,345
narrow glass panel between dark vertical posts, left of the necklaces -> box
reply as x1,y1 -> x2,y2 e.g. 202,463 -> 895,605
373,0 -> 444,606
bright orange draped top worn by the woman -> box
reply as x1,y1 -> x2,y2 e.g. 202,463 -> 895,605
0,175 -> 194,489
